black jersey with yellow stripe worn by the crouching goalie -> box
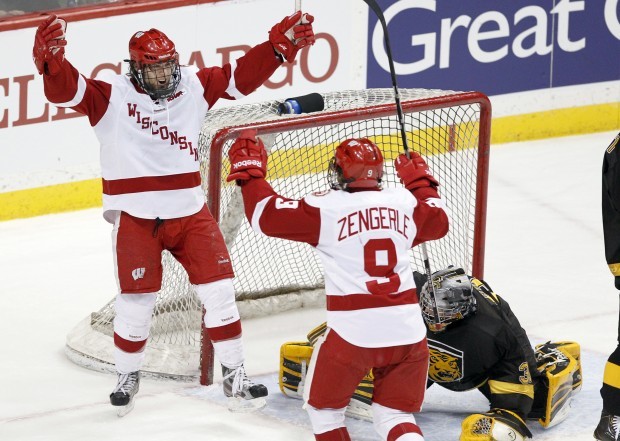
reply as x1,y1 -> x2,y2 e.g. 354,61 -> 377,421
427,278 -> 538,418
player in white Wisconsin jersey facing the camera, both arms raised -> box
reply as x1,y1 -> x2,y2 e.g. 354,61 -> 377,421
33,11 -> 314,415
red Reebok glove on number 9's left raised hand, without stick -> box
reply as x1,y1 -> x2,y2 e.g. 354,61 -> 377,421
226,129 -> 267,185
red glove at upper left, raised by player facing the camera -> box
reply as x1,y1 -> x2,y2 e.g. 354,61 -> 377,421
32,14 -> 67,75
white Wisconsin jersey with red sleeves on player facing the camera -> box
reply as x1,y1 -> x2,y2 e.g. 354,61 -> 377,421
44,42 -> 281,222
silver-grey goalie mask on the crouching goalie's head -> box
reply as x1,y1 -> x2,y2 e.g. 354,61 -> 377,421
420,266 -> 478,332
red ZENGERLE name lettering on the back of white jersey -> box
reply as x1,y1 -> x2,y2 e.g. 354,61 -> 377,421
338,207 -> 410,242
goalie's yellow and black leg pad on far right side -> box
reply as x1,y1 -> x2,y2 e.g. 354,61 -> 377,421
535,341 -> 582,428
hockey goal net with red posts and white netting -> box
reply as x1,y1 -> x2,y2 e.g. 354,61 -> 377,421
66,89 -> 491,384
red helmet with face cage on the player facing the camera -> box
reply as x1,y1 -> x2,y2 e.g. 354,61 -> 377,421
129,29 -> 181,100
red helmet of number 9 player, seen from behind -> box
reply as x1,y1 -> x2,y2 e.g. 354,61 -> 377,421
327,138 -> 383,190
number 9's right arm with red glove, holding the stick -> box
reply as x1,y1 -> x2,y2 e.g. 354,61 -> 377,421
394,152 -> 449,246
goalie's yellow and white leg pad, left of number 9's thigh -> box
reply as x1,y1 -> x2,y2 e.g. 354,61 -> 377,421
278,341 -> 314,399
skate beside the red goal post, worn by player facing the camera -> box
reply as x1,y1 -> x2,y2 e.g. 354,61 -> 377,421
222,365 -> 268,412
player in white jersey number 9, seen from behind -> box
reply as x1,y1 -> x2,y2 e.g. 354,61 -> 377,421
228,130 -> 448,441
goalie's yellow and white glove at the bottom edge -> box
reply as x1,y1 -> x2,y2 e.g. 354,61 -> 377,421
459,409 -> 532,441
